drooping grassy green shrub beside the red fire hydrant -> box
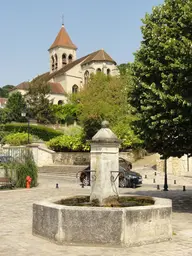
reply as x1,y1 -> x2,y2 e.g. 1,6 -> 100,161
4,150 -> 38,188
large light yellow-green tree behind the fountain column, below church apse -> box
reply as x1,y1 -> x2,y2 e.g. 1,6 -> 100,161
76,73 -> 140,147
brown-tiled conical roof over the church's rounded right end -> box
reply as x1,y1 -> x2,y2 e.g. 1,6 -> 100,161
81,49 -> 116,65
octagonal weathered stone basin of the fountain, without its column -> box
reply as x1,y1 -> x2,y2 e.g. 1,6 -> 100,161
32,197 -> 172,247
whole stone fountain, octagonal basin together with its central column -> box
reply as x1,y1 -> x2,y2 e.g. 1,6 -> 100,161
33,121 -> 172,247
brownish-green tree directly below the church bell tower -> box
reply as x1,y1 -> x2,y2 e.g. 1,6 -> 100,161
25,79 -> 55,123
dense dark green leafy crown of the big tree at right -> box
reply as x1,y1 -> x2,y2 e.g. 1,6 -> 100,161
130,0 -> 192,159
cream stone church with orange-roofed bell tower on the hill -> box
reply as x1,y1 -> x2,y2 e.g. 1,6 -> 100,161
11,25 -> 119,104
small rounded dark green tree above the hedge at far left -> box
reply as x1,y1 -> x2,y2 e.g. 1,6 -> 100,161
4,92 -> 26,122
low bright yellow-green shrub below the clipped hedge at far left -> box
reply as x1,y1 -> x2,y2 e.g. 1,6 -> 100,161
4,132 -> 32,146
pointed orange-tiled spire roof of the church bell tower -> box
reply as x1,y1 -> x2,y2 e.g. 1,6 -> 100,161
49,25 -> 77,50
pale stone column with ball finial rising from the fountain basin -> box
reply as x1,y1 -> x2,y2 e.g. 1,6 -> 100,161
90,121 -> 120,205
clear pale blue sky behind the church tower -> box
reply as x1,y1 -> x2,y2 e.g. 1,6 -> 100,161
0,0 -> 164,87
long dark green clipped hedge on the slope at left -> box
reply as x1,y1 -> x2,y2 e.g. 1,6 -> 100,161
0,123 -> 63,141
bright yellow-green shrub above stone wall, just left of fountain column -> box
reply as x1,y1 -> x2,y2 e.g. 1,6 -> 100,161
47,134 -> 90,152
